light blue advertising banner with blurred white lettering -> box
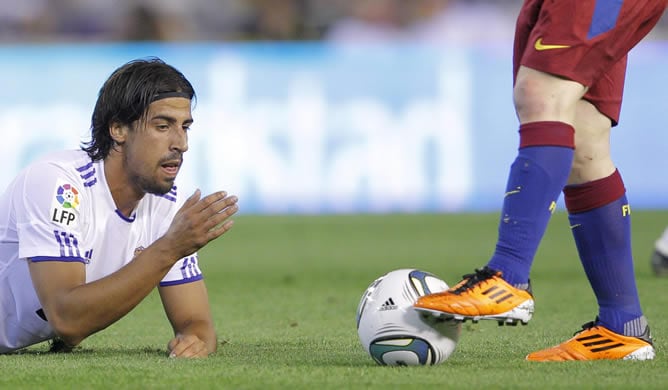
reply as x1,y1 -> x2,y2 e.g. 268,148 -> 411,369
0,42 -> 668,213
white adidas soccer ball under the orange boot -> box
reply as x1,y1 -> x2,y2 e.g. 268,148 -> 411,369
357,269 -> 461,366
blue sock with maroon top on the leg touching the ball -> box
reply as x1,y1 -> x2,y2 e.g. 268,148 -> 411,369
487,122 -> 574,288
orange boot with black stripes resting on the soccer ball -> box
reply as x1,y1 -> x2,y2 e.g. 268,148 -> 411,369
414,267 -> 534,325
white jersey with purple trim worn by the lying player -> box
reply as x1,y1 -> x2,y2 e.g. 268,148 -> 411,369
0,150 -> 202,353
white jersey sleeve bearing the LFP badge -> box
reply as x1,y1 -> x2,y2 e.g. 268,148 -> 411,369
12,161 -> 86,263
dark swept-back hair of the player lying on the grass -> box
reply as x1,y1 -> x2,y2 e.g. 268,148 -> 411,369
81,57 -> 196,161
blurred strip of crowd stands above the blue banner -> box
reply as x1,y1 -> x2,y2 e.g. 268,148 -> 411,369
0,0 -> 668,43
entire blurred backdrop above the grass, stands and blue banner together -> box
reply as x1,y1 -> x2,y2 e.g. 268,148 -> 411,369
0,0 -> 668,213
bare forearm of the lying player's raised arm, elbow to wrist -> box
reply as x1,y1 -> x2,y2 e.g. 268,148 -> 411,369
45,240 -> 183,346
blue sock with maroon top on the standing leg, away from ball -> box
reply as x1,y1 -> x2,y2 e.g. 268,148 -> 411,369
564,171 -> 647,336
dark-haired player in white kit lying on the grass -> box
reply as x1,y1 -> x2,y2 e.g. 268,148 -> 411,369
0,58 -> 238,357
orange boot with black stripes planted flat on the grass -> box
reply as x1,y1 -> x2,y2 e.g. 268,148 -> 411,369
526,321 -> 655,362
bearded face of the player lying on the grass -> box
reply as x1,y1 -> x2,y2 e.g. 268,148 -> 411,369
124,97 -> 193,195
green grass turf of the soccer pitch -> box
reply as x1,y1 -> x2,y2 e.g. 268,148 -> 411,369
0,211 -> 668,389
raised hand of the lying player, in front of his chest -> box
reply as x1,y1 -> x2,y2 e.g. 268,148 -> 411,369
164,190 -> 239,258
